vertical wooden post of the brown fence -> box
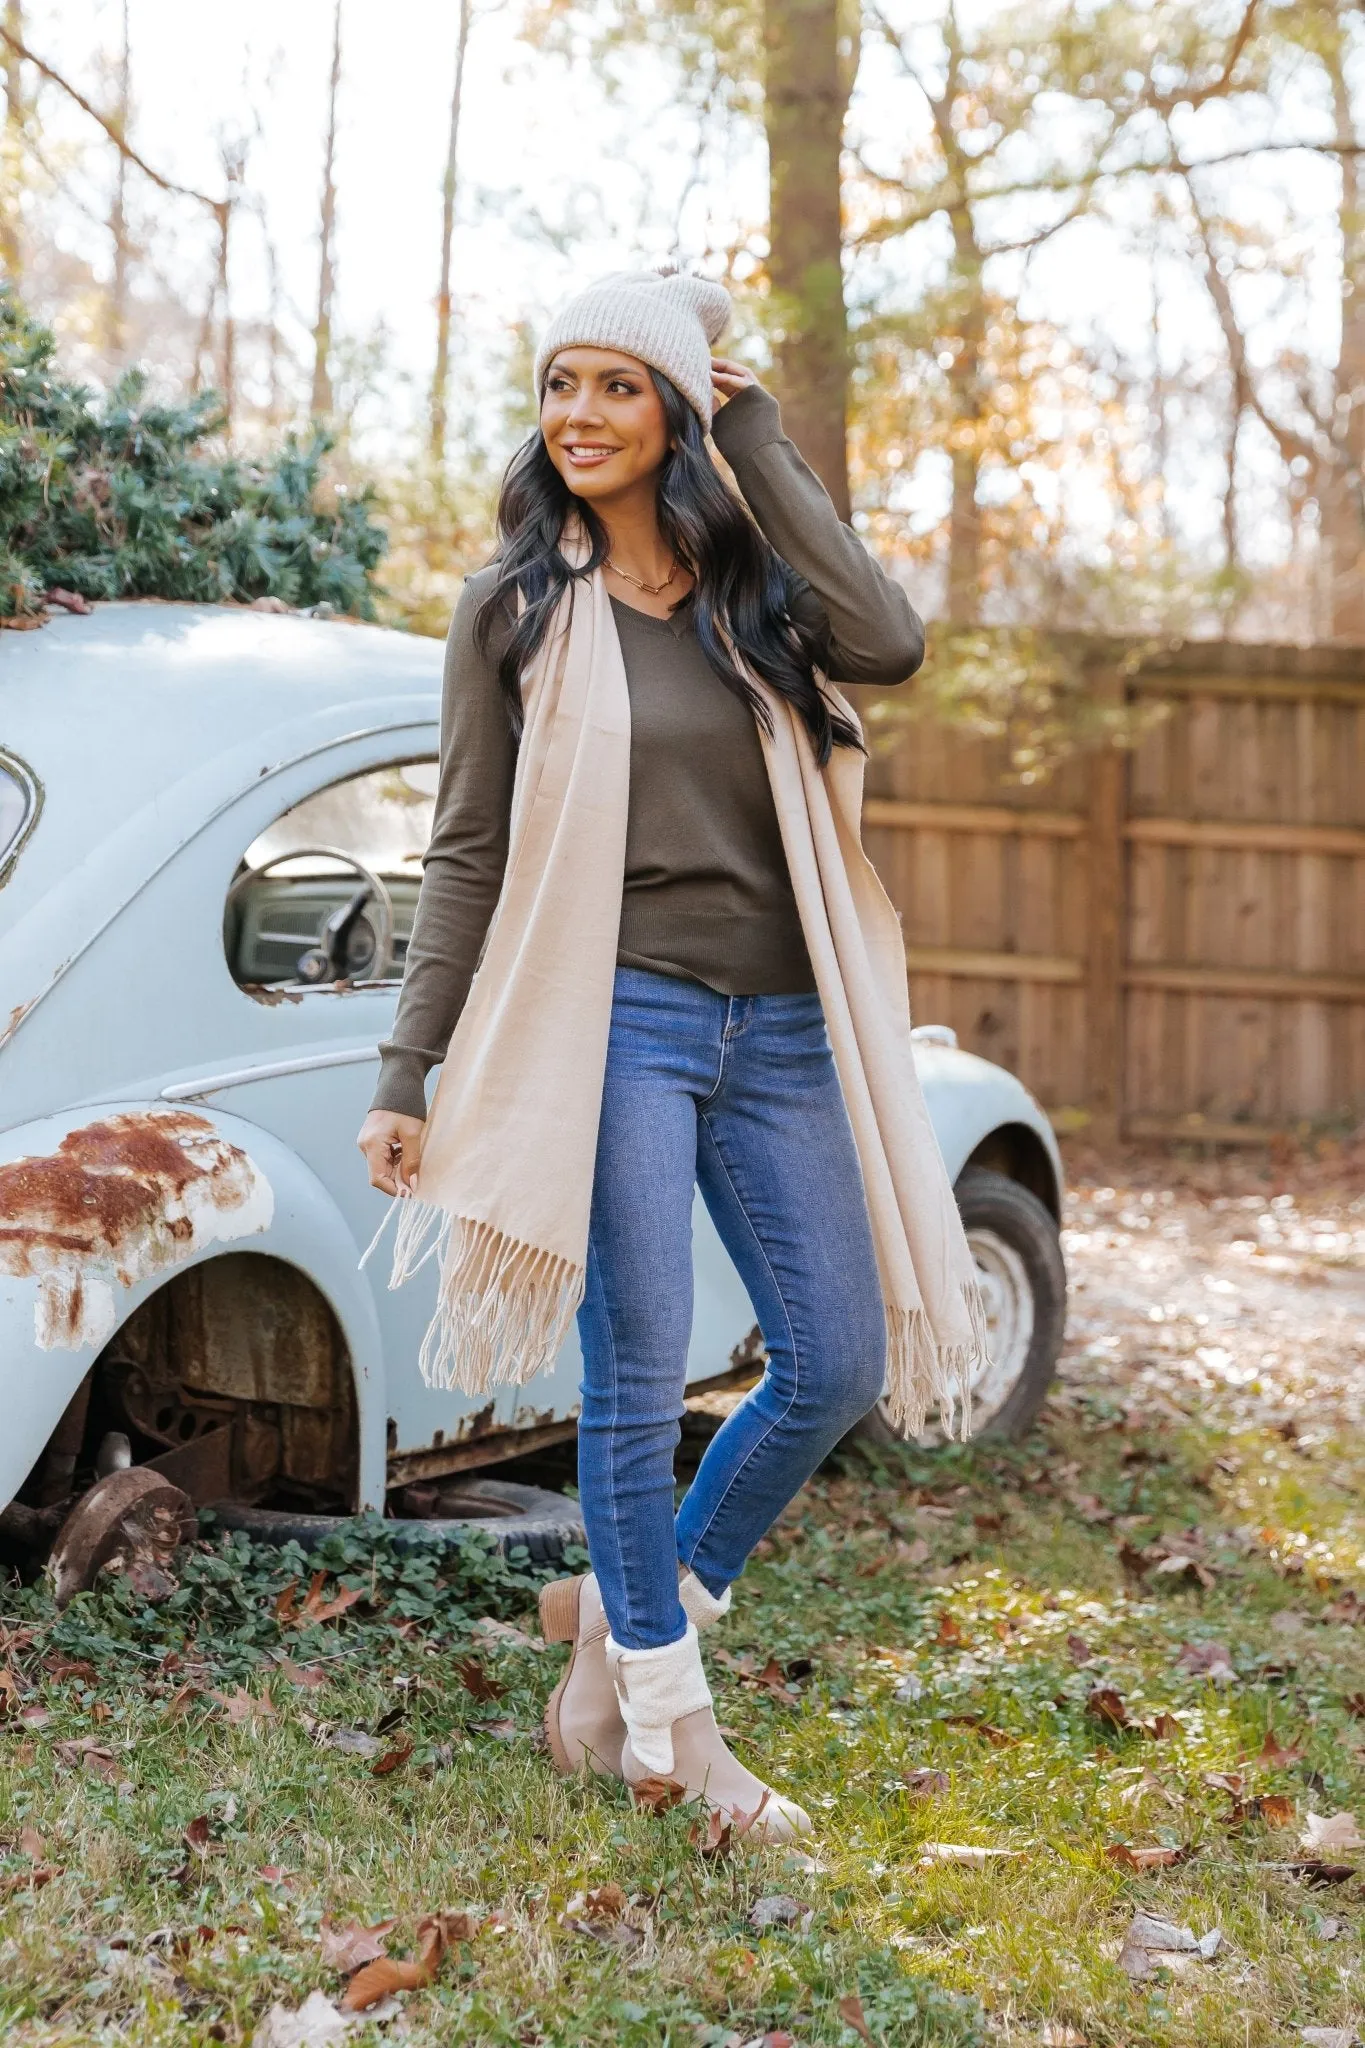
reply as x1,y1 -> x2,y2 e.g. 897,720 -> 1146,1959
1085,670 -> 1128,1145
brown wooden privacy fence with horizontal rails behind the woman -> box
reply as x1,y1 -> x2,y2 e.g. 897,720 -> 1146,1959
860,641 -> 1365,1143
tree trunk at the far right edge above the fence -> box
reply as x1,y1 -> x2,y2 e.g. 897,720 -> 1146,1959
1320,28 -> 1365,641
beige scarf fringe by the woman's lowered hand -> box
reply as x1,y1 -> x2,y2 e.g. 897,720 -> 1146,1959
389,1198 -> 583,1395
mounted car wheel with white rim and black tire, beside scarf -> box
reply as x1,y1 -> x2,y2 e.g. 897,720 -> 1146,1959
849,1167 -> 1066,1446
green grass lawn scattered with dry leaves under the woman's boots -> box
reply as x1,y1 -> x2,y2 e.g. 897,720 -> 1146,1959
0,1171 -> 1365,2048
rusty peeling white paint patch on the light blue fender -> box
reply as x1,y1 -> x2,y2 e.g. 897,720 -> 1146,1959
0,1110 -> 274,1352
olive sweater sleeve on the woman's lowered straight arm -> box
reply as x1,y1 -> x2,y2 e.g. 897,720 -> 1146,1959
370,573 -> 516,1116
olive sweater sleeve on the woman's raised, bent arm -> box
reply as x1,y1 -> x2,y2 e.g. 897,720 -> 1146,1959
710,385 -> 925,684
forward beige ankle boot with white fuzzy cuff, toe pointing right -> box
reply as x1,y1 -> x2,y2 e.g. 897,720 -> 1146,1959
606,1622 -> 810,1841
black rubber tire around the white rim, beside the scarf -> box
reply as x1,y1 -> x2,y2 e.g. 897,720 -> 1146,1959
849,1167 -> 1066,1444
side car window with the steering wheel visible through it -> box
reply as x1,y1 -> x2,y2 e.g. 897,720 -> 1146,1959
223,760 -> 436,993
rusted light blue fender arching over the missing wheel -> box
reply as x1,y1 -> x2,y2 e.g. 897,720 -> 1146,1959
0,1102 -> 385,1507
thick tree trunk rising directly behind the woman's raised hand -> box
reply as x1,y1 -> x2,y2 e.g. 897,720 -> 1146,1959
763,0 -> 849,518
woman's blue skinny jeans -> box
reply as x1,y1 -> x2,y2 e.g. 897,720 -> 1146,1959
579,967 -> 886,1649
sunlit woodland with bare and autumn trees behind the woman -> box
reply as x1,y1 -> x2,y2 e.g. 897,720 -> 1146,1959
0,0 -> 1365,671
